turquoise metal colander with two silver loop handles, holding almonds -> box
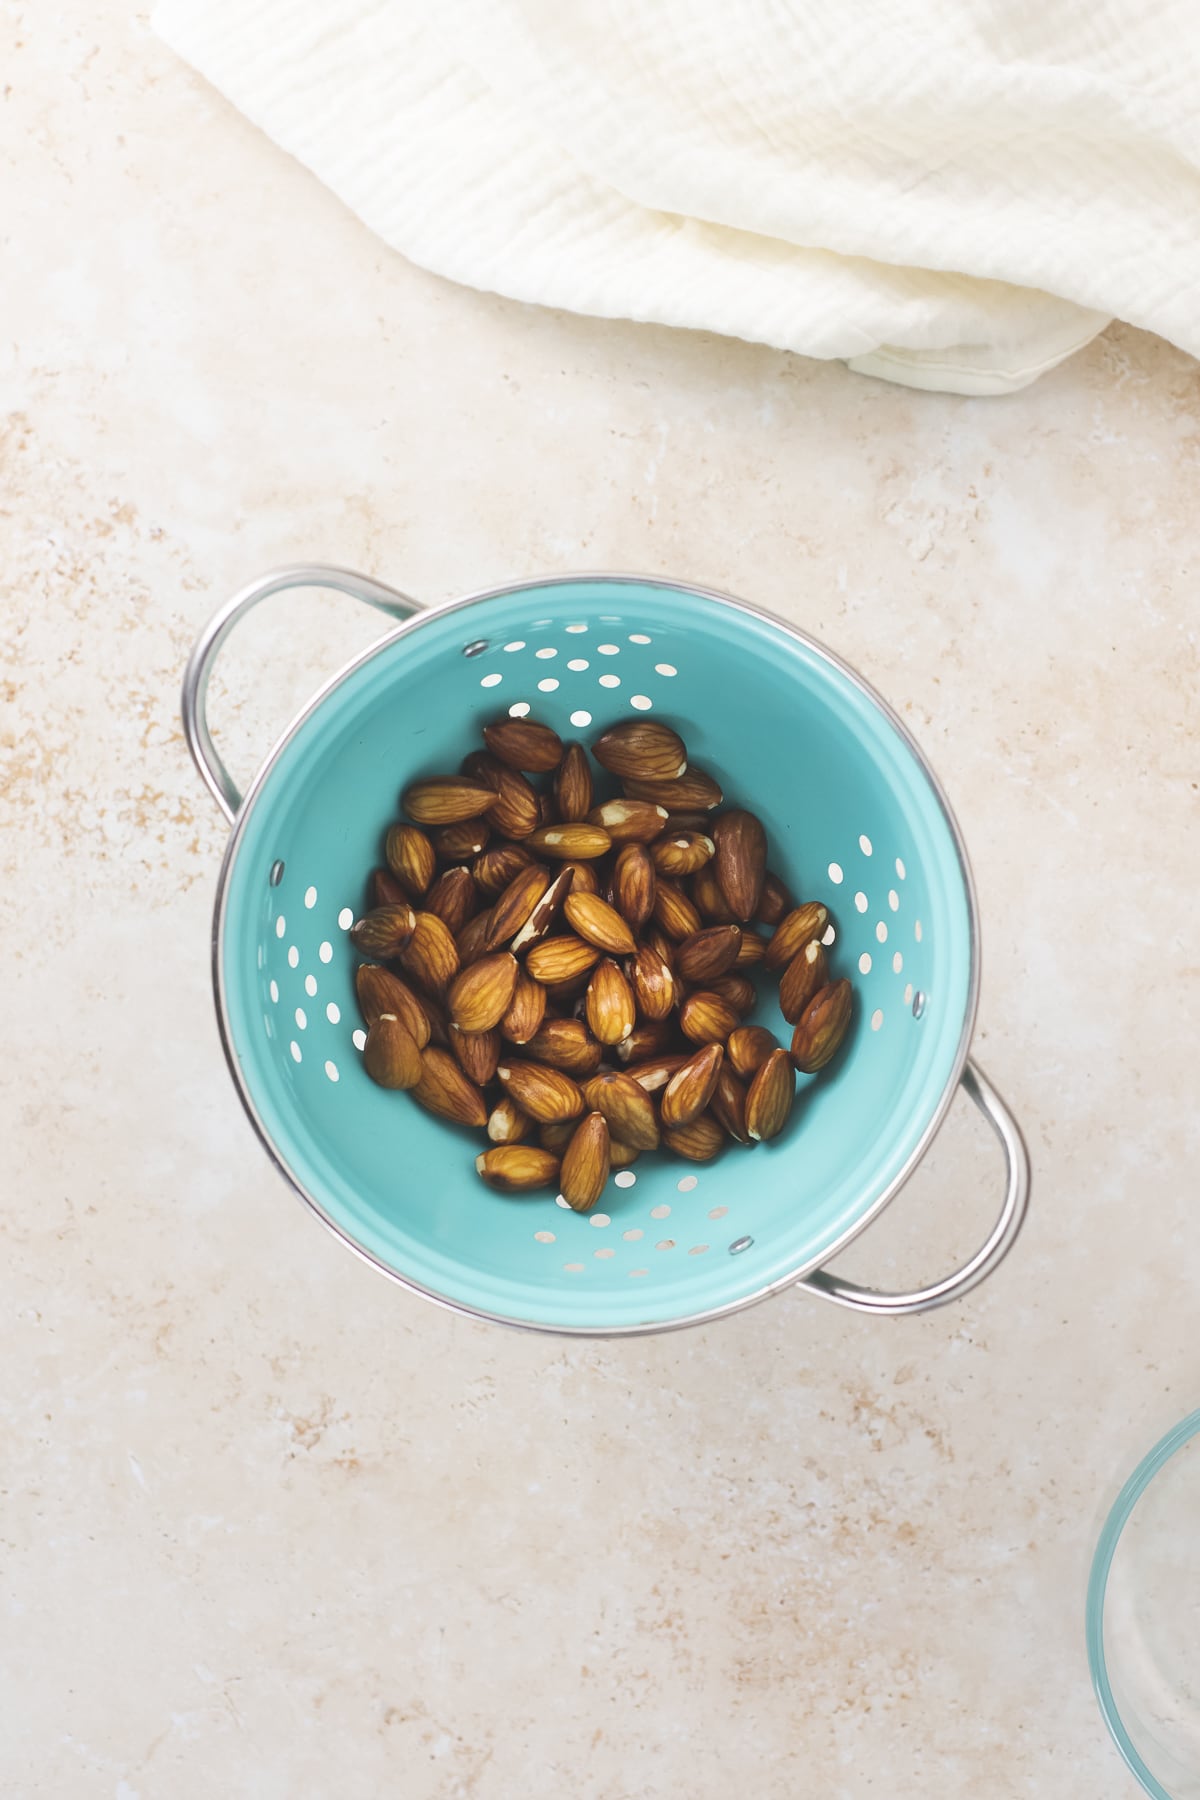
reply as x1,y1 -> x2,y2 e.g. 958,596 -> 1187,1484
184,565 -> 1029,1336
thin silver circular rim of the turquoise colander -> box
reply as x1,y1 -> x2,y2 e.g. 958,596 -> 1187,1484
212,572 -> 981,1337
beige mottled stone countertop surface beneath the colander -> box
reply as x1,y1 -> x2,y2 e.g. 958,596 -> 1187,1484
0,0 -> 1200,1800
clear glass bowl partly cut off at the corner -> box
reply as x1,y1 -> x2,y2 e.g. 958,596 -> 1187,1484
1087,1411 -> 1200,1800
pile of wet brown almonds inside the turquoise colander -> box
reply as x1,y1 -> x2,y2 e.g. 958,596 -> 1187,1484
351,718 -> 851,1213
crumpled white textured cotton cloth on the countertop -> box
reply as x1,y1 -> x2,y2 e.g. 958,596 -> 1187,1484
153,0 -> 1200,394
